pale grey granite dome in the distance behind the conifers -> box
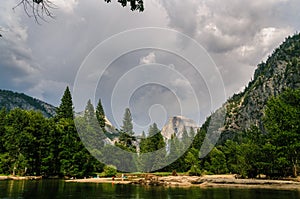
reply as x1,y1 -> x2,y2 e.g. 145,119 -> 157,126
161,116 -> 199,140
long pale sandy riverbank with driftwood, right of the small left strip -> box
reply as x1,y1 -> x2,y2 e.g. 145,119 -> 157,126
66,175 -> 300,190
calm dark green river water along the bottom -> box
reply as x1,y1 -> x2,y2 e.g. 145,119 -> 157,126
0,180 -> 300,199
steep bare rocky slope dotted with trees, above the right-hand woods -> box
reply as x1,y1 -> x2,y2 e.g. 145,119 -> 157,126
218,34 -> 300,137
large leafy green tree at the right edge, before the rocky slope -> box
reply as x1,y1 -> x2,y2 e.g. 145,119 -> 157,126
264,89 -> 300,177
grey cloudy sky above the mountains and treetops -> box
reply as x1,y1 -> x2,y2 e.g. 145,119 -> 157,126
0,0 -> 300,134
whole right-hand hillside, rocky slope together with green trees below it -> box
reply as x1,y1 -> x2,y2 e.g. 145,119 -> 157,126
190,34 -> 300,177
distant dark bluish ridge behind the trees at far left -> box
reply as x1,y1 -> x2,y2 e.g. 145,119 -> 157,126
0,90 -> 56,117
